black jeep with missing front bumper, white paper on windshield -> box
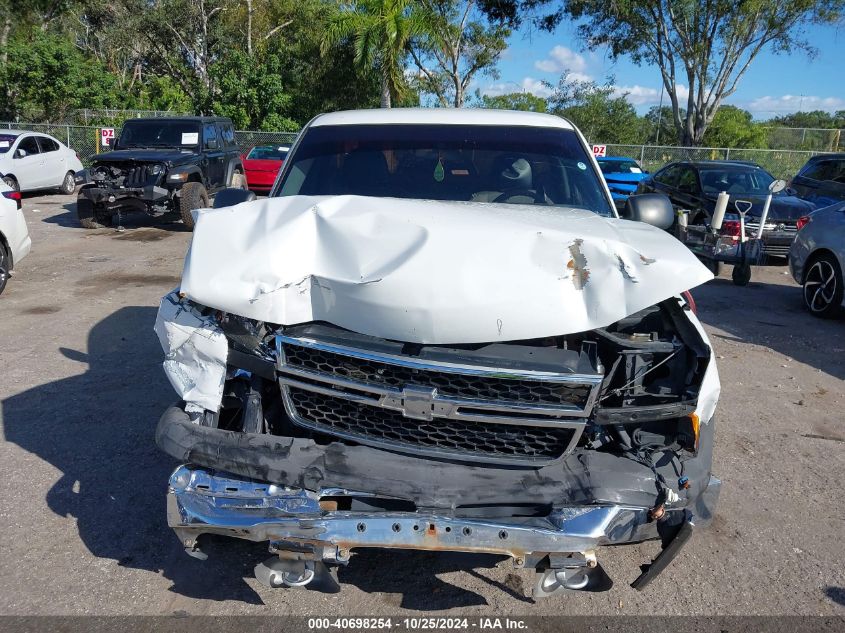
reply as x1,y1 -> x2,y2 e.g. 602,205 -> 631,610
76,117 -> 247,229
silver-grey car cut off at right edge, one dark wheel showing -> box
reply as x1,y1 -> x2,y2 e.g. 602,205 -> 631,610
789,202 -> 845,318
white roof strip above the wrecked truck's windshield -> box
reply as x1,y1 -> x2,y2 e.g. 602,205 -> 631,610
311,108 -> 574,130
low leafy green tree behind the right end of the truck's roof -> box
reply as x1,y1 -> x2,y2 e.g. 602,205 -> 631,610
549,73 -> 642,144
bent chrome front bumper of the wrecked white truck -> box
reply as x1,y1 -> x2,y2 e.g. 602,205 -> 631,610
167,466 -> 721,566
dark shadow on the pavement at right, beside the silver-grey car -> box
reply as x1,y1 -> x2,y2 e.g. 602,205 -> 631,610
692,269 -> 845,379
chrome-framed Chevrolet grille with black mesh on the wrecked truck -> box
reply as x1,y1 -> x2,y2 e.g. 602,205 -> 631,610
276,335 -> 602,464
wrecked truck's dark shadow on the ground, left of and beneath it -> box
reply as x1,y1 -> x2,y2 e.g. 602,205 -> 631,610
2,307 -> 526,610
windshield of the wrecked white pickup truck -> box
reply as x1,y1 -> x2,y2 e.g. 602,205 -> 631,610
275,125 -> 614,216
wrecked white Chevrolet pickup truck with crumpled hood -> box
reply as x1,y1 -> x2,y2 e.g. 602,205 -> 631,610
156,109 -> 720,596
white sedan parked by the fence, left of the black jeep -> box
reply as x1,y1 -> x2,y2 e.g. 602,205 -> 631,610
0,130 -> 82,193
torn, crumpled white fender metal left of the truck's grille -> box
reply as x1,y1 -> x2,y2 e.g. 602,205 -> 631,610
155,292 -> 229,413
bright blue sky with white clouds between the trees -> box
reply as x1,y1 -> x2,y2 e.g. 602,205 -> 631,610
476,19 -> 845,119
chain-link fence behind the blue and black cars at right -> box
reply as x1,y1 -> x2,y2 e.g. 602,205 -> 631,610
607,145 -> 823,180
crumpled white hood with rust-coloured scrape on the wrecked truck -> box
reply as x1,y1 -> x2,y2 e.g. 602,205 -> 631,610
181,196 -> 712,344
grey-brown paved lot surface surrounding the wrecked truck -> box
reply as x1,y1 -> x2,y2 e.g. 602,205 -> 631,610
0,195 -> 845,616
